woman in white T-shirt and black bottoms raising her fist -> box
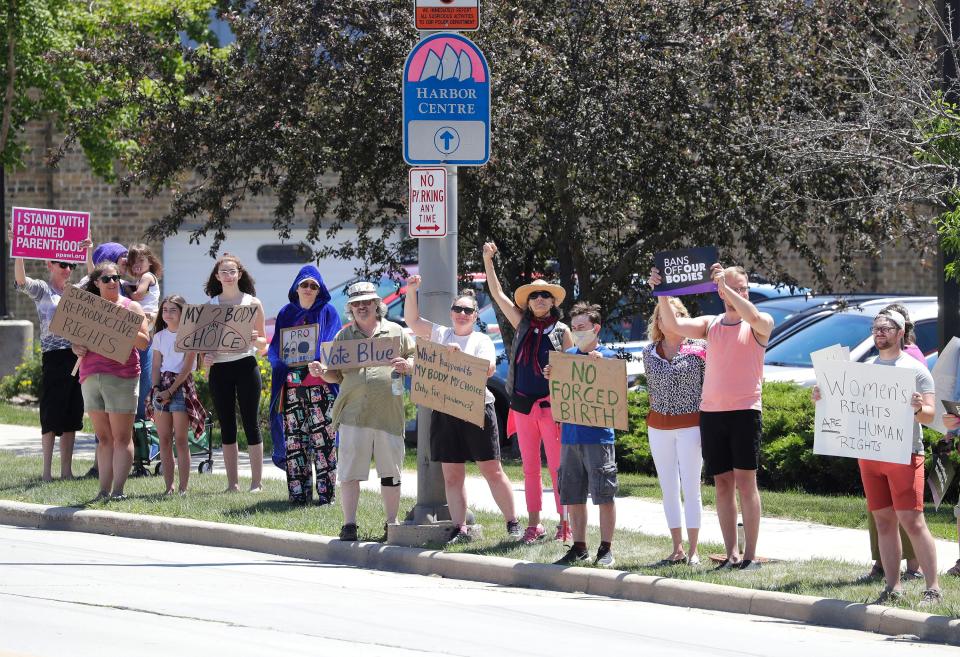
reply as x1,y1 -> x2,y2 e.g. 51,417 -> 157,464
403,275 -> 520,543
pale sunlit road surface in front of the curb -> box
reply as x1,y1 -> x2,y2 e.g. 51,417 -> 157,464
0,526 -> 957,657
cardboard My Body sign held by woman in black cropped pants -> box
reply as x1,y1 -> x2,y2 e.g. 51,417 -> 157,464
173,303 -> 258,354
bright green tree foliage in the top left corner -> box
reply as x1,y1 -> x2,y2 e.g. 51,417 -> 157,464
0,0 -> 214,178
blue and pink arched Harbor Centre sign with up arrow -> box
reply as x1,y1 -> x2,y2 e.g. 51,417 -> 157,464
403,32 -> 490,166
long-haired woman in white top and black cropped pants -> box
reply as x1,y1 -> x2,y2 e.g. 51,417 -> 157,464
203,253 -> 267,493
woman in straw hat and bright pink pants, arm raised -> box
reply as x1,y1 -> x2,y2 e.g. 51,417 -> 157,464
483,242 -> 573,545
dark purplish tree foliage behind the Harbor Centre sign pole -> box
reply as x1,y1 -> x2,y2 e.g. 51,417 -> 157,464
58,0 -> 922,328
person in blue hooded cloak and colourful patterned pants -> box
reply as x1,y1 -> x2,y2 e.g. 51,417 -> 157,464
267,265 -> 340,504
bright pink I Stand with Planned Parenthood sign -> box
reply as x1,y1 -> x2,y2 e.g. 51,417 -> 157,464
10,208 -> 90,262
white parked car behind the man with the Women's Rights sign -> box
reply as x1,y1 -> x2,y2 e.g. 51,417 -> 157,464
763,297 -> 937,386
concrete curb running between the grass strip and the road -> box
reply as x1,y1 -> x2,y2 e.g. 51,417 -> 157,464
0,501 -> 960,646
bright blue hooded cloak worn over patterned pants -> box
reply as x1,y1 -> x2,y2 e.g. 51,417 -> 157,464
267,265 -> 341,470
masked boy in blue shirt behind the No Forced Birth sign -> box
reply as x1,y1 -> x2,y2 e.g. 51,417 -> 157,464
543,302 -> 626,568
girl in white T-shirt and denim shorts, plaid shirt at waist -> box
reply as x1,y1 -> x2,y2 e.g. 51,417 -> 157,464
145,294 -> 207,495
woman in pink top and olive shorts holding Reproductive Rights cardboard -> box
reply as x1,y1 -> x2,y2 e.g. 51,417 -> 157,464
73,261 -> 150,500
